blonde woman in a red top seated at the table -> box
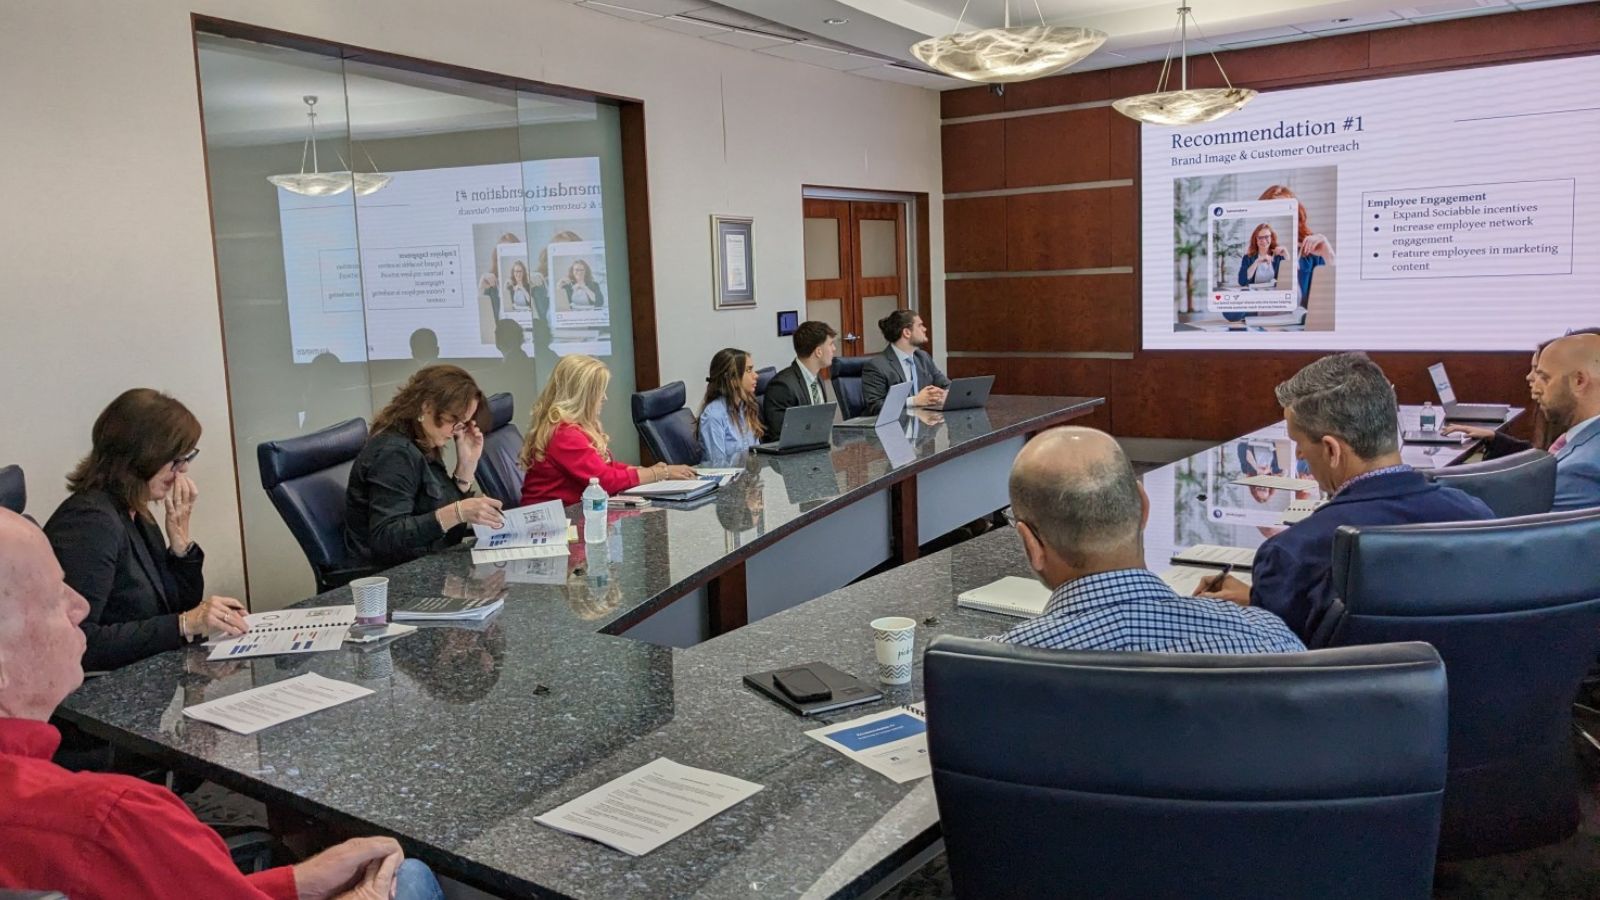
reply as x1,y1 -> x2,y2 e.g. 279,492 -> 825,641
520,354 -> 694,506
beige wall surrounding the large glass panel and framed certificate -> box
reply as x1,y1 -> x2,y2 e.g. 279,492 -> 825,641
0,0 -> 944,605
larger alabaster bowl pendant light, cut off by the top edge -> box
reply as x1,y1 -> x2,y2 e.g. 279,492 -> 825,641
910,0 -> 1106,85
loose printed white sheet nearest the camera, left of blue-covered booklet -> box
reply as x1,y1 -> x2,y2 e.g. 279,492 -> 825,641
534,756 -> 762,857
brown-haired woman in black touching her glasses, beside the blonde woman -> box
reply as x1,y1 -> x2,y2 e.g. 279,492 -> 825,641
344,365 -> 504,567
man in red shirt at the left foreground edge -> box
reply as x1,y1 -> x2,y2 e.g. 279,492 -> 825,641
0,509 -> 443,900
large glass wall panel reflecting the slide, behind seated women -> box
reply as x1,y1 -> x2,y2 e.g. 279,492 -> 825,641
198,35 -> 637,609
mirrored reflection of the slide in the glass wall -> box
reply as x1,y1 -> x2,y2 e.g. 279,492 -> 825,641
278,157 -> 611,364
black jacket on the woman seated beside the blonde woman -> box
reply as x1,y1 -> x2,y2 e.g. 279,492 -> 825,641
344,431 -> 467,565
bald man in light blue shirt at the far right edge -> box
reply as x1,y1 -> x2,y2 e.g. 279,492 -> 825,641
1534,335 -> 1600,509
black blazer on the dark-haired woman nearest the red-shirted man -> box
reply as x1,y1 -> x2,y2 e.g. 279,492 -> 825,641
45,490 -> 205,671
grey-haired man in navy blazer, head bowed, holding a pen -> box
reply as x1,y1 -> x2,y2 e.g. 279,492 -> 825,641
1195,354 -> 1494,641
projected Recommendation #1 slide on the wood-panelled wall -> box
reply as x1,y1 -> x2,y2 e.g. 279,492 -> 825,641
1141,56 -> 1600,351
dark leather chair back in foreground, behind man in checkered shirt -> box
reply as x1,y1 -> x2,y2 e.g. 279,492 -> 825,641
925,636 -> 1446,900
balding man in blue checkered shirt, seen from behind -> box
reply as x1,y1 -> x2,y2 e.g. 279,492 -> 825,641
1000,428 -> 1306,653
